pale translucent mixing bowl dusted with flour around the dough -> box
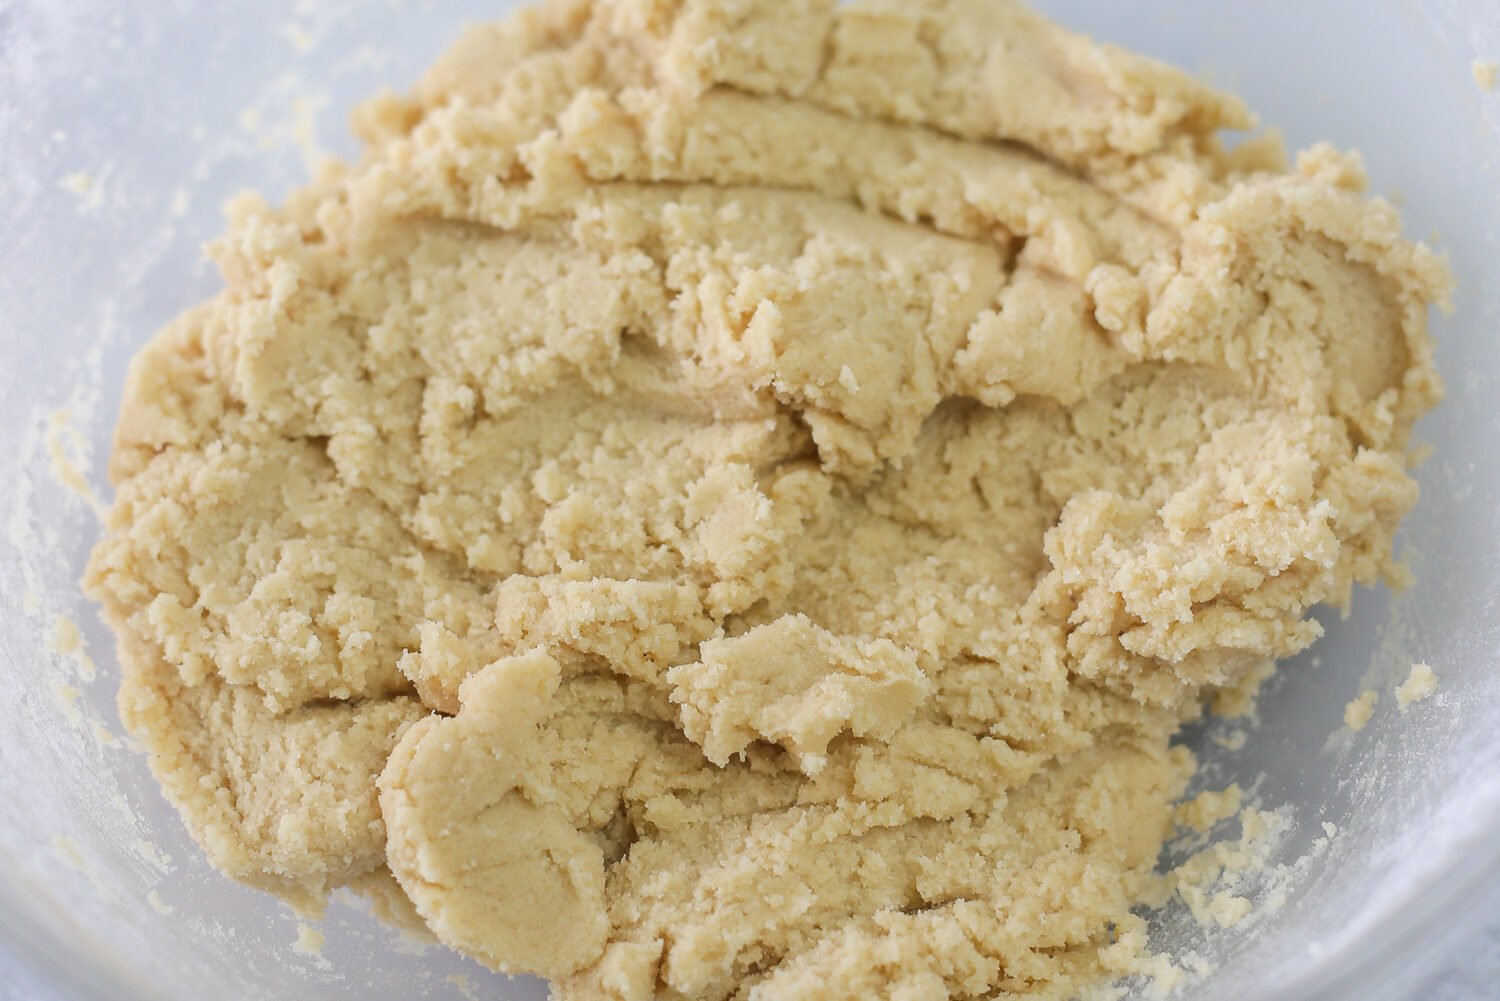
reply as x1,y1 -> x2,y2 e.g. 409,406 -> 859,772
0,0 -> 1500,1001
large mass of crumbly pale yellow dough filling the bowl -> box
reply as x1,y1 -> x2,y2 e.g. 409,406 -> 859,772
87,0 -> 1448,1001
